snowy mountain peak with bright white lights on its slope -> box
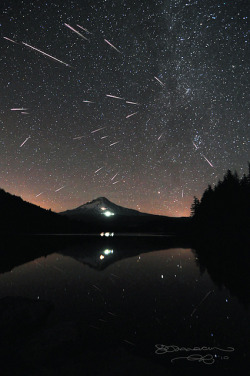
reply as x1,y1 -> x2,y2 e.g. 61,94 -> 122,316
60,197 -> 143,219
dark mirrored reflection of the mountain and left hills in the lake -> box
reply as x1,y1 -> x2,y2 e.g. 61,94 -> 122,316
0,235 -> 189,273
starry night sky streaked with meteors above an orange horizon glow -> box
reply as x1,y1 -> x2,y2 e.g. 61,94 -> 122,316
0,0 -> 250,216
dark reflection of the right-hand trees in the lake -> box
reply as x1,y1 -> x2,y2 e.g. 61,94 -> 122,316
194,239 -> 250,307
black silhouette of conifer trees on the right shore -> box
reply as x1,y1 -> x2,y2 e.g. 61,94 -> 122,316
191,163 -> 250,239
